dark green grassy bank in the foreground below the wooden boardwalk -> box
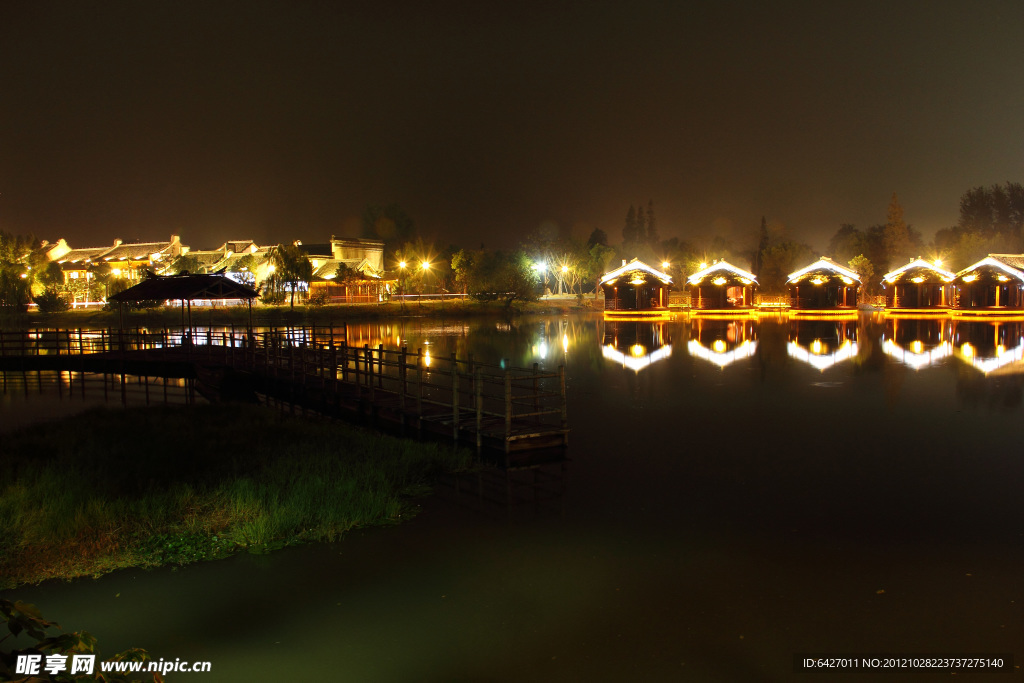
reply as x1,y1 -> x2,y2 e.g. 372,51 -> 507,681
0,404 -> 470,589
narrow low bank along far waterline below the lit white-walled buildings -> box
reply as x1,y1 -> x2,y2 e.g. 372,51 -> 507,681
6,297 -> 600,329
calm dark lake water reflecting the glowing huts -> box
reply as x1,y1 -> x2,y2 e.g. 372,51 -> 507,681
0,316 -> 1024,681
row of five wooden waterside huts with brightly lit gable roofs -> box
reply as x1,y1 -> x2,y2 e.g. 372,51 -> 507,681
601,254 -> 1024,316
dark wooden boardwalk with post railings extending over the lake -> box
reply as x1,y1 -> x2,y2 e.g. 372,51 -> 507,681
0,326 -> 568,453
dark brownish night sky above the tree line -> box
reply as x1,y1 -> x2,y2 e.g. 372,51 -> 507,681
0,0 -> 1024,253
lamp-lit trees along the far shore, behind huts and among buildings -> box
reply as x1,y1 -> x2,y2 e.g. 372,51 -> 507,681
6,182 -> 1024,308
